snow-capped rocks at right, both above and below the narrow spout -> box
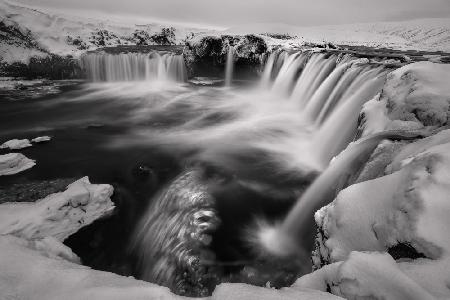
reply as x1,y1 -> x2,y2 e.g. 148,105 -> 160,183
304,62 -> 450,299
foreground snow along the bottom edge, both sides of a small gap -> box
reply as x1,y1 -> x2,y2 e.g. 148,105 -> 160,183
0,235 -> 342,300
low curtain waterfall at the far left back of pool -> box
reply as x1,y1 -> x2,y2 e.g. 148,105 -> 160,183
81,52 -> 187,82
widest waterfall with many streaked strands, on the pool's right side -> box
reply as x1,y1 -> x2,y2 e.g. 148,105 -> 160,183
260,51 -> 385,169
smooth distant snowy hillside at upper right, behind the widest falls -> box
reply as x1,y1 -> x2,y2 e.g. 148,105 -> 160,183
227,18 -> 450,52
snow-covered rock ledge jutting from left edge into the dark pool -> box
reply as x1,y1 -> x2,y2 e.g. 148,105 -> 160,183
0,177 -> 114,241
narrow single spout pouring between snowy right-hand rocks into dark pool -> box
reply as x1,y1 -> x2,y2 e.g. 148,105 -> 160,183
256,131 -> 422,256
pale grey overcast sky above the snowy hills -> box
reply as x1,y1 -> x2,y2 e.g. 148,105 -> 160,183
14,0 -> 450,27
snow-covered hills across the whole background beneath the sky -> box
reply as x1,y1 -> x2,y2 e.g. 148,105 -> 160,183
0,0 -> 450,63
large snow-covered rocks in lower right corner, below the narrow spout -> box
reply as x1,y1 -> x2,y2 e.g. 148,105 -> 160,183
312,130 -> 450,299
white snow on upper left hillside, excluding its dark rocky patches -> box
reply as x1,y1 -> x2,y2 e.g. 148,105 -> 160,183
0,0 -> 213,63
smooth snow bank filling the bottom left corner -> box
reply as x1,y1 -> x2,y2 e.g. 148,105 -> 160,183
0,236 -> 183,300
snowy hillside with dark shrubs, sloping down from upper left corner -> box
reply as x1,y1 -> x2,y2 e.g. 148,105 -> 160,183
0,0 -> 216,63
